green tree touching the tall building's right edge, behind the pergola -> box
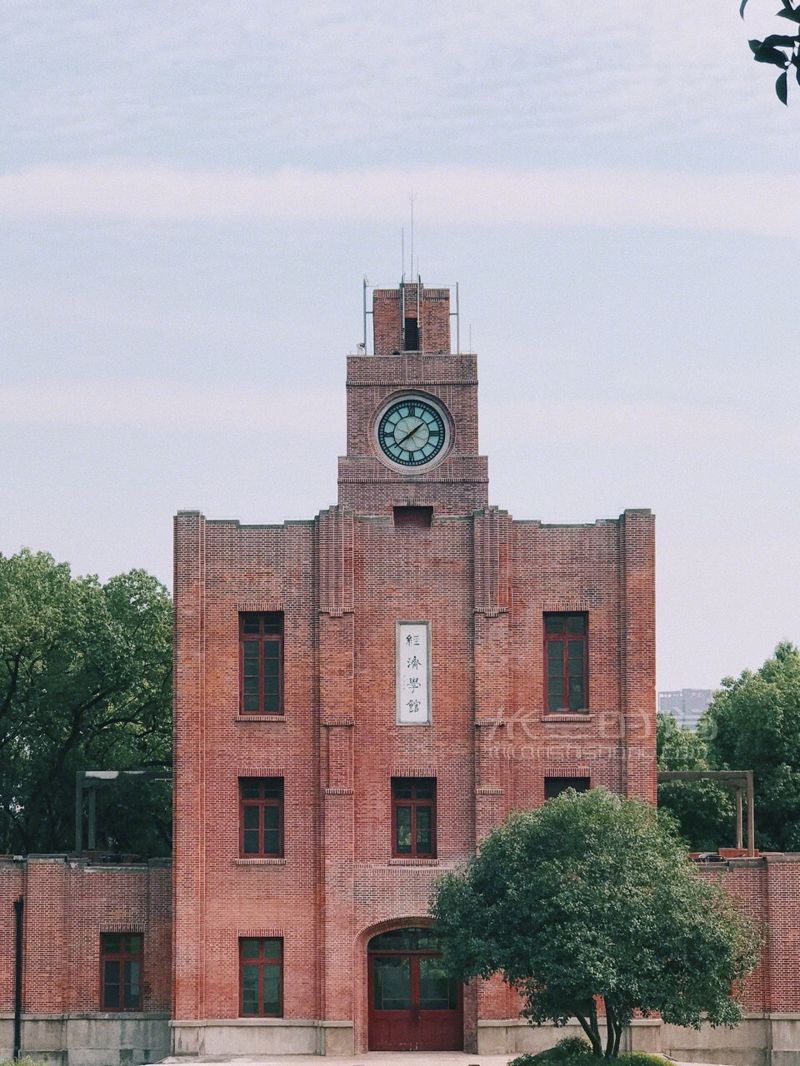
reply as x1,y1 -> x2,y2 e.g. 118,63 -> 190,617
656,714 -> 738,852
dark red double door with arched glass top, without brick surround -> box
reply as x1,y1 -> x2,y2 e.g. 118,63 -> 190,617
367,926 -> 464,1051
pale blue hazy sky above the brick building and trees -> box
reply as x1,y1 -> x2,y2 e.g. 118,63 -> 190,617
0,0 -> 800,689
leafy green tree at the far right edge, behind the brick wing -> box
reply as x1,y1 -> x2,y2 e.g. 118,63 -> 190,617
704,644 -> 800,852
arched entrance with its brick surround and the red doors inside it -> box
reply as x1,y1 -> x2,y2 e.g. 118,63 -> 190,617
353,917 -> 476,1051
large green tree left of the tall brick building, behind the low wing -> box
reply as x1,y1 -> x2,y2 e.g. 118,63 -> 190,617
0,550 -> 172,855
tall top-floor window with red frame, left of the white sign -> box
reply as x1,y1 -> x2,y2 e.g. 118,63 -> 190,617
239,611 -> 284,714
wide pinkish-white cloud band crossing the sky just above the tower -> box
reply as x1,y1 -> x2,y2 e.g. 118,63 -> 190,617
0,163 -> 800,238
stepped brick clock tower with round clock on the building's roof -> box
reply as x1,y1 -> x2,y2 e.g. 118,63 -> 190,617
339,279 -> 489,515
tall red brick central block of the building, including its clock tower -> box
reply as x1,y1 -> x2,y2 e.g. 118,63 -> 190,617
173,282 -> 655,1054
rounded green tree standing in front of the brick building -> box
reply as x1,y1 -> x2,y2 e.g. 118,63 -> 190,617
431,789 -> 758,1057
